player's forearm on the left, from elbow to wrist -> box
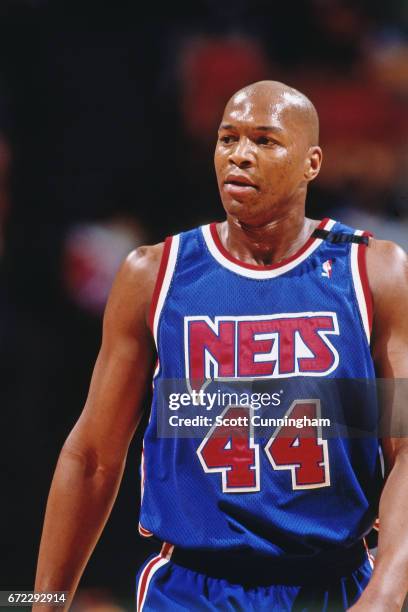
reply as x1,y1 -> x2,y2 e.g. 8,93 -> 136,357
34,447 -> 124,612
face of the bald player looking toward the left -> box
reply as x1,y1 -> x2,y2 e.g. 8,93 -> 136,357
214,91 -> 310,225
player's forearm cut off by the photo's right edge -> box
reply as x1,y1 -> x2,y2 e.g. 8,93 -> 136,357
359,451 -> 408,612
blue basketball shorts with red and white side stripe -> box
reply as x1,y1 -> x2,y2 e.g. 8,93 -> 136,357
136,544 -> 372,612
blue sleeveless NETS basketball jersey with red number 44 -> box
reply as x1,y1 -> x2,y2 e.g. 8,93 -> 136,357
140,219 -> 381,558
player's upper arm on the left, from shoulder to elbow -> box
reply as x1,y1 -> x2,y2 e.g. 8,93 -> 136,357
62,249 -> 158,466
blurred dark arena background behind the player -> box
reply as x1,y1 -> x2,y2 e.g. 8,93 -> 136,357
0,0 -> 408,610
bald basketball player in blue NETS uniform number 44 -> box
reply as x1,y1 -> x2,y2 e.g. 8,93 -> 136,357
36,81 -> 408,612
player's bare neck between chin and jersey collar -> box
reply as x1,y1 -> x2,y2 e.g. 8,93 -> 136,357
217,211 -> 317,266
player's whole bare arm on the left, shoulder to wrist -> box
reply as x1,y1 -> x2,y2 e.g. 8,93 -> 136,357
35,245 -> 162,612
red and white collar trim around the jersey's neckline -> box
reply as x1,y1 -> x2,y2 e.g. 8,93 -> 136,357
201,218 -> 336,279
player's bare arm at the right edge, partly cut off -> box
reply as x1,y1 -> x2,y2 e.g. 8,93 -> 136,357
351,240 -> 408,612
